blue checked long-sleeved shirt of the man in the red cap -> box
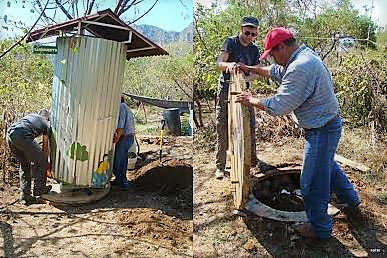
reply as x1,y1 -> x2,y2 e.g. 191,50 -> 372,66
263,44 -> 338,129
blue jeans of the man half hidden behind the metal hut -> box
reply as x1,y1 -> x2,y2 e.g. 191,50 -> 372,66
113,134 -> 134,185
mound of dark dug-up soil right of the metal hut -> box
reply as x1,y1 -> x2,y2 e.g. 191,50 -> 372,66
131,159 -> 193,196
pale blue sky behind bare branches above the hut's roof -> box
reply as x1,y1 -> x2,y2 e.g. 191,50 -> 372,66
0,0 -> 193,36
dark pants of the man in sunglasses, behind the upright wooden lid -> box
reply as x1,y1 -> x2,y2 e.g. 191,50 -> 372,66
216,81 -> 257,170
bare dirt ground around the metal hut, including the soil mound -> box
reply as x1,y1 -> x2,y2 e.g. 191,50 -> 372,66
0,136 -> 193,257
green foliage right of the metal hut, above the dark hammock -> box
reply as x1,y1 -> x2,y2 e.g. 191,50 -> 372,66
124,42 -> 193,100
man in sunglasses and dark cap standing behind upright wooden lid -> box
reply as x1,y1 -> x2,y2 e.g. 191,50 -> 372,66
215,16 -> 259,179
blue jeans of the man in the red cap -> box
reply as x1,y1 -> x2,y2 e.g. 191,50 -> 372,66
300,117 -> 359,239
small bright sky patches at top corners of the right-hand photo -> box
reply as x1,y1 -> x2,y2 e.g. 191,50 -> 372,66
194,0 -> 387,27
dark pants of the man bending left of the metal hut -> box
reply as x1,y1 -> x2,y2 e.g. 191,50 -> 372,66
6,129 -> 47,198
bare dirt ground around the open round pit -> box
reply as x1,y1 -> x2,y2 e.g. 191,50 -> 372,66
193,110 -> 387,257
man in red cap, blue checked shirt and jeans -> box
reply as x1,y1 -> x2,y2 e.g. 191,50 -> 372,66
237,27 -> 360,239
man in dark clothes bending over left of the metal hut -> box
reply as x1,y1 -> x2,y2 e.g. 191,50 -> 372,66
6,110 -> 51,205
